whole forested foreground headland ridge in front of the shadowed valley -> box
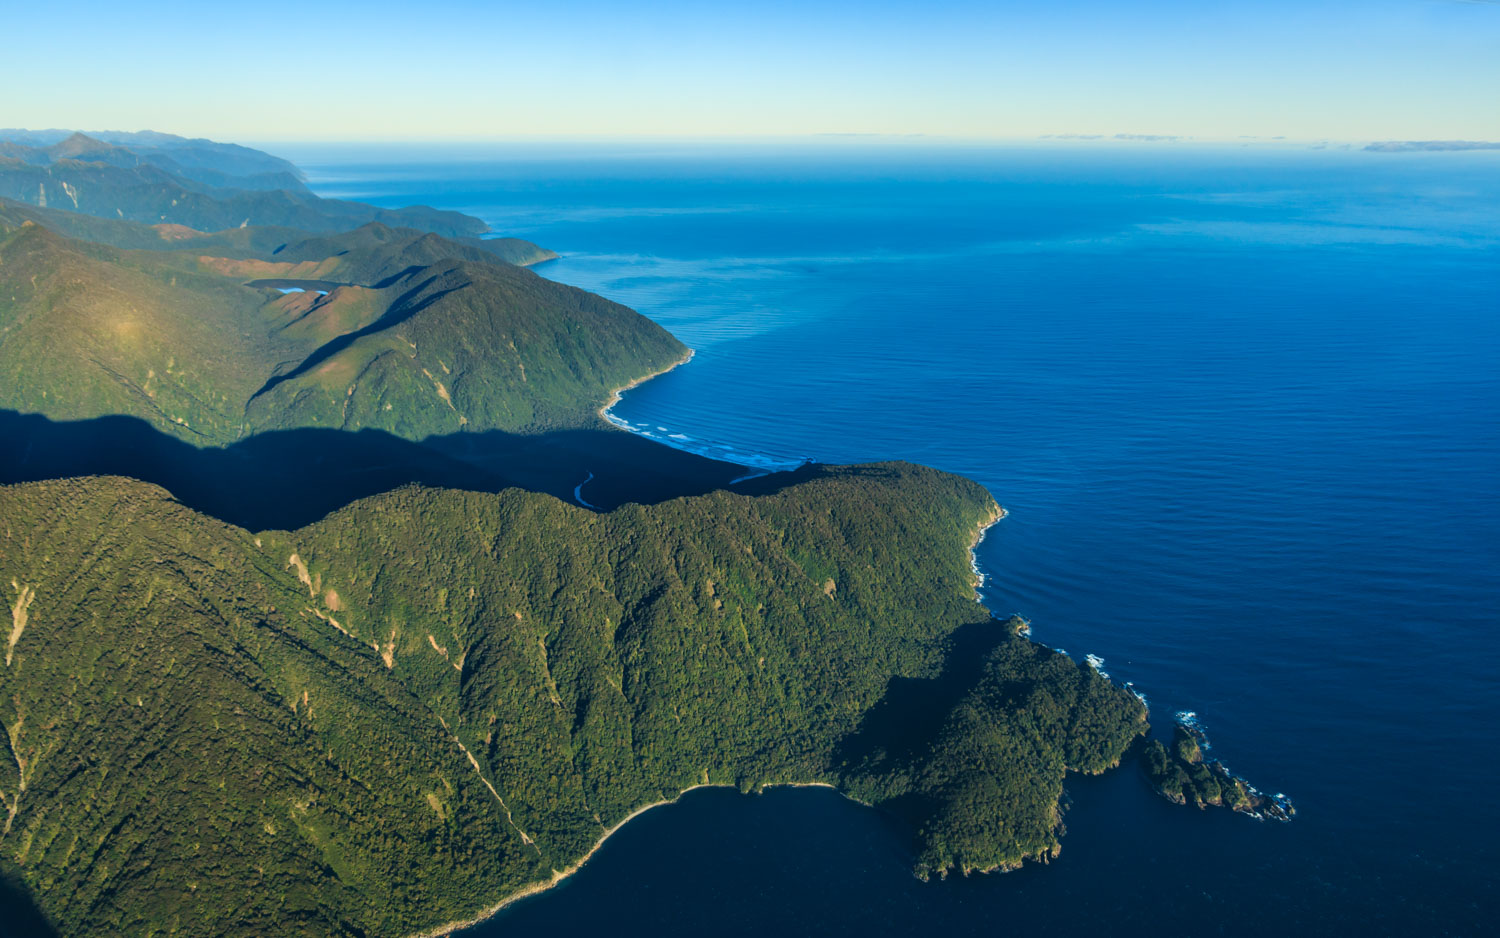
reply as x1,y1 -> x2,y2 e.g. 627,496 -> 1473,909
0,465 -> 1143,935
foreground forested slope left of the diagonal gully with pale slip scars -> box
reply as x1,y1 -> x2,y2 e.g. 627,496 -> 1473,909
0,479 -> 537,935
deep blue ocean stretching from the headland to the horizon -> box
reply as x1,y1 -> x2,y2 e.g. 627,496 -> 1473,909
284,146 -> 1500,935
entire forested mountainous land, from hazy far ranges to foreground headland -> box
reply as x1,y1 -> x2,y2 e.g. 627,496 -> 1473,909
0,135 -> 1271,936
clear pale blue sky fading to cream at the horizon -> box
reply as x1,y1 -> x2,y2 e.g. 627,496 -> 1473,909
0,0 -> 1500,143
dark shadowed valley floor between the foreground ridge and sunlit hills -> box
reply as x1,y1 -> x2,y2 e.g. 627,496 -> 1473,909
0,410 -> 812,530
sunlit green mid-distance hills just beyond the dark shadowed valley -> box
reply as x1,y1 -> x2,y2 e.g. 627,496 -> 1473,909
0,219 -> 686,444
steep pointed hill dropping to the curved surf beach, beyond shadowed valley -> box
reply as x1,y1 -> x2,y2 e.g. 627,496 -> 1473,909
246,253 -> 686,440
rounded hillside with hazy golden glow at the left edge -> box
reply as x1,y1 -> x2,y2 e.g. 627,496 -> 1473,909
0,225 -> 276,443
